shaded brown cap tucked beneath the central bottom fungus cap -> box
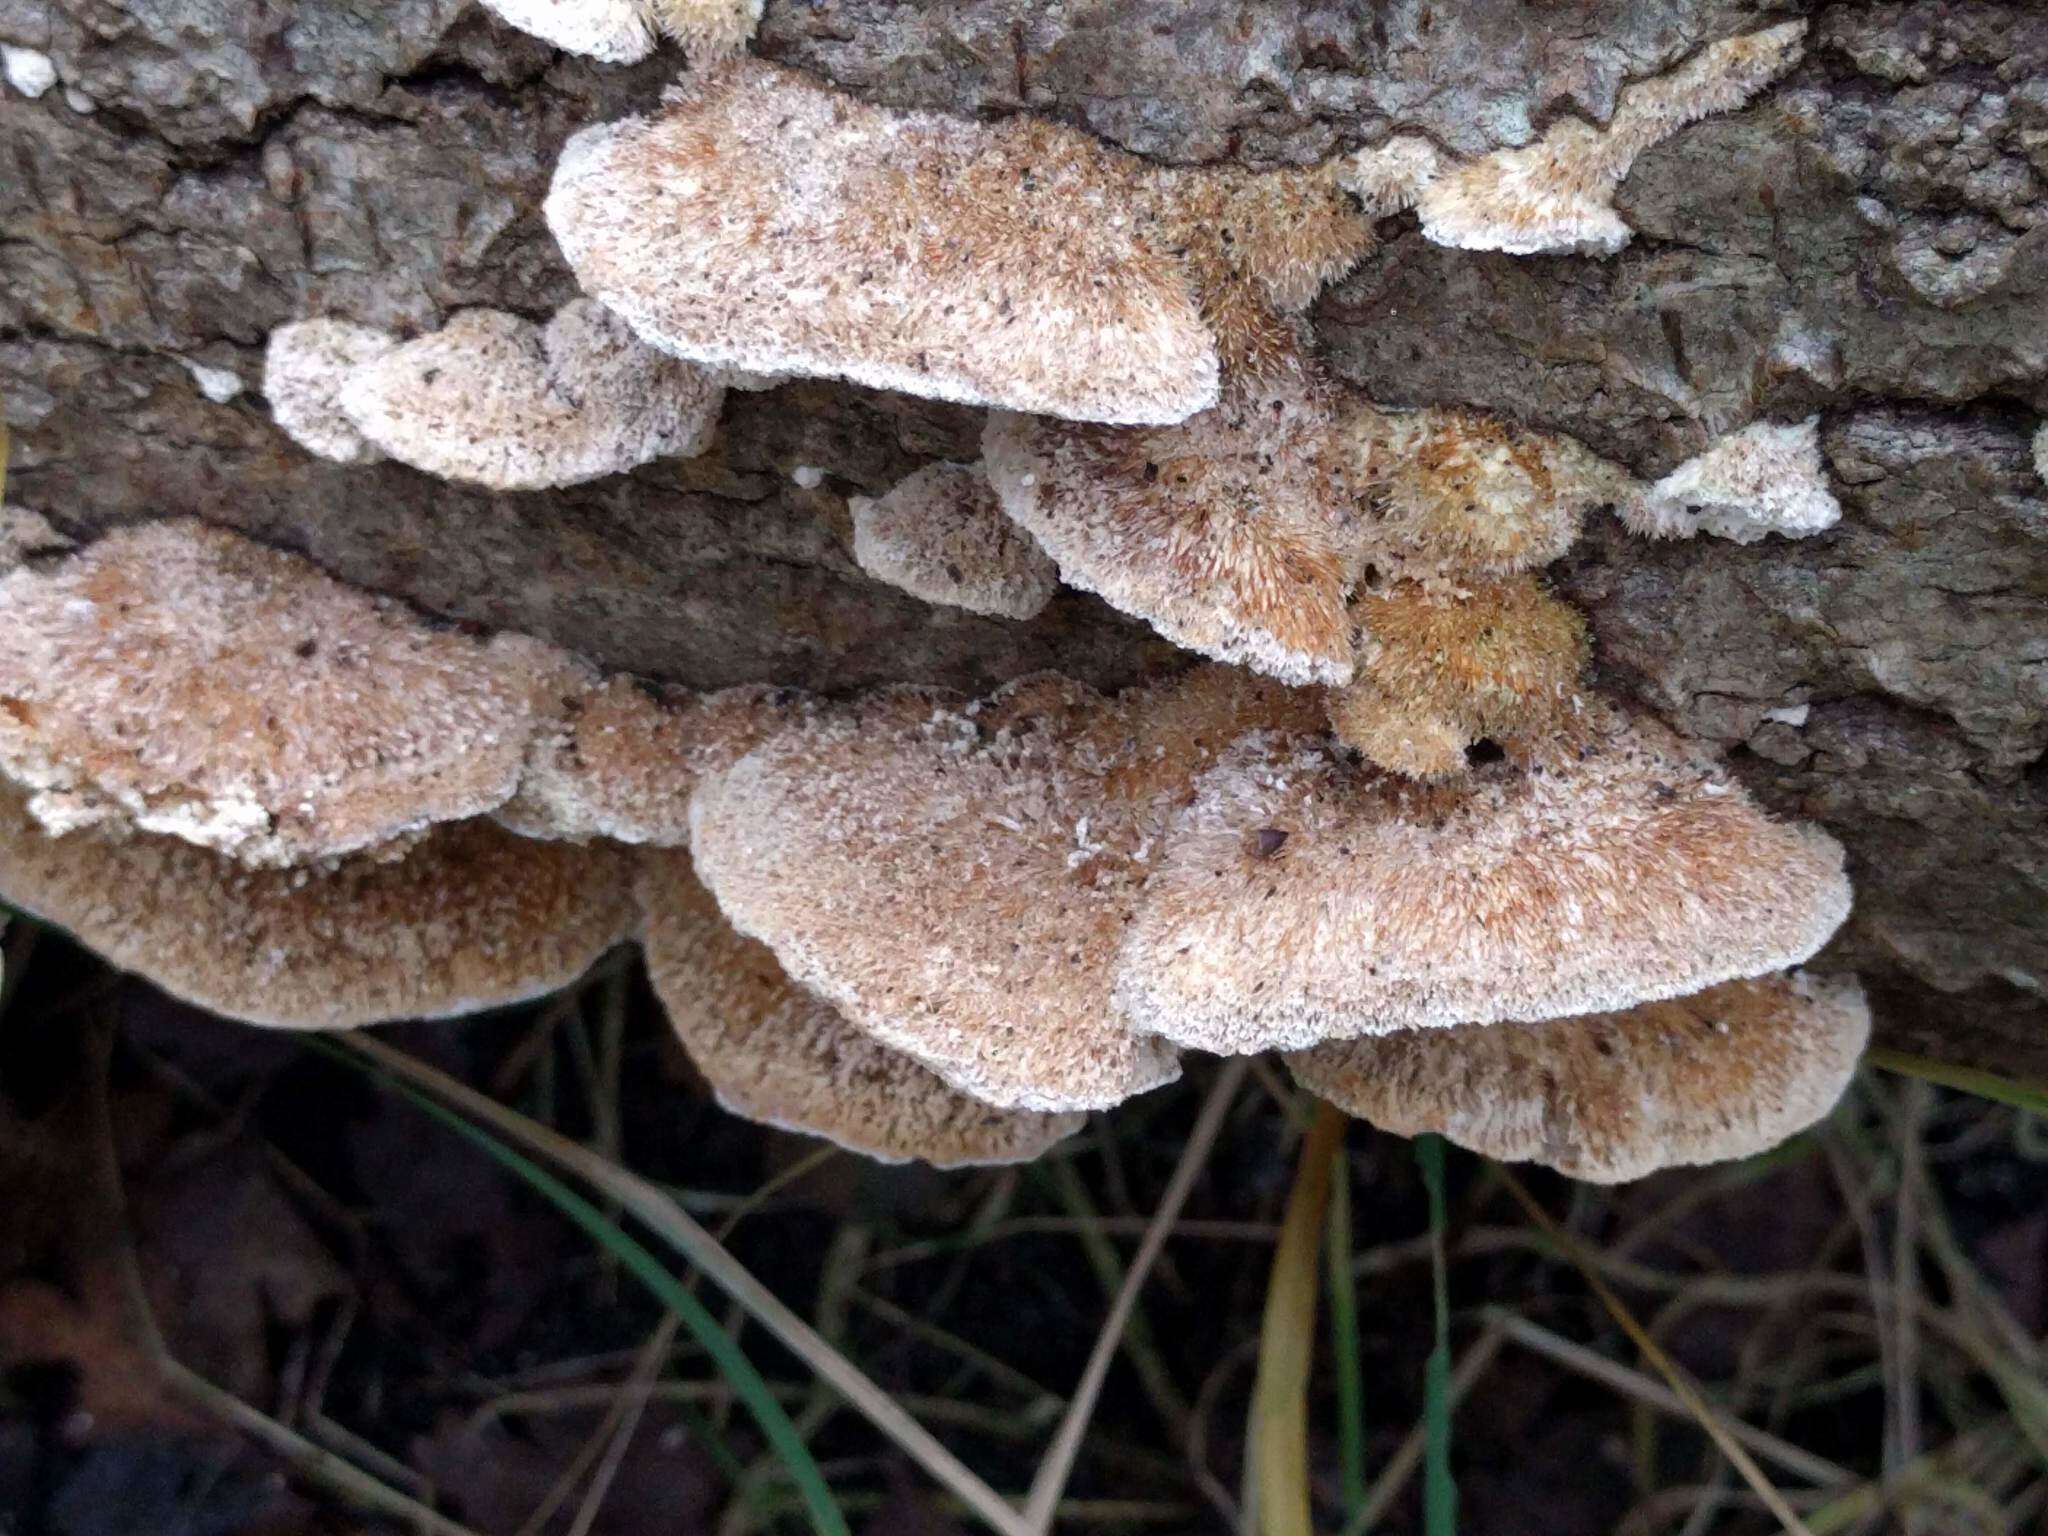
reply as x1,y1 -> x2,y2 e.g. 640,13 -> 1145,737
639,854 -> 1087,1167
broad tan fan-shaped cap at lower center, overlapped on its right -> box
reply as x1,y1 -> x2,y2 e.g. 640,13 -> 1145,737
690,668 -> 1315,1110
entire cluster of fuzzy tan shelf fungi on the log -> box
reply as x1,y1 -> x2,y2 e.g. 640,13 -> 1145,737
24,20 -> 1870,1180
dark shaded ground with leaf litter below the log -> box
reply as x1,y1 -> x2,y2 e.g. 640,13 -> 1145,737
0,926 -> 2048,1536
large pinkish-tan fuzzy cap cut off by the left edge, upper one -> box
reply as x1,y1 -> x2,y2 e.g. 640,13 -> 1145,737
0,520 -> 571,864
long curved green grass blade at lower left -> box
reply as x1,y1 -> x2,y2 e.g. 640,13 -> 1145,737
376,1083 -> 848,1536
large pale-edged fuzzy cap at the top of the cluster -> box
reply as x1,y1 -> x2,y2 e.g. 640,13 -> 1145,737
547,59 -> 1219,422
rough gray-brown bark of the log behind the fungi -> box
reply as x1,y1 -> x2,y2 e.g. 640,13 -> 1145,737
0,0 -> 2048,1071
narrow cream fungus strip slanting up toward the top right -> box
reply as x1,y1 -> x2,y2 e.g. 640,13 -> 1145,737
1417,20 -> 1806,256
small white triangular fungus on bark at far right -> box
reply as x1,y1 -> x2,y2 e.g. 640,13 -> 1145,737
1620,416 -> 1841,545
